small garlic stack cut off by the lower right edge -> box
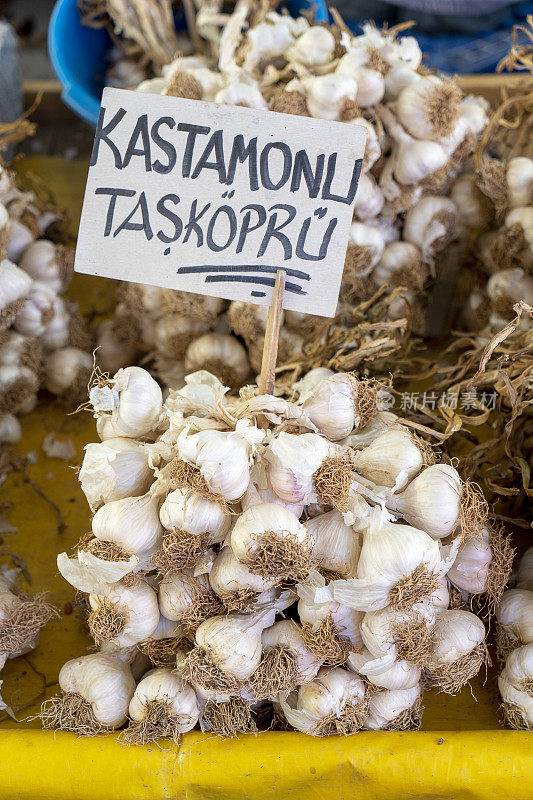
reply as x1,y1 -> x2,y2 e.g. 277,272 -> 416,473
496,547 -> 533,731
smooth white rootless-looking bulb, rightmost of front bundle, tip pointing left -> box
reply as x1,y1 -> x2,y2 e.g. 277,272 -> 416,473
386,464 -> 462,539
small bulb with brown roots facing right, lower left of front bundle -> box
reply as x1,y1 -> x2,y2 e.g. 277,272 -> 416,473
159,569 -> 222,631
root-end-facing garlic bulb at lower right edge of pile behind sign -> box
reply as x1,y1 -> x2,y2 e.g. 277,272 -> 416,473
403,195 -> 461,263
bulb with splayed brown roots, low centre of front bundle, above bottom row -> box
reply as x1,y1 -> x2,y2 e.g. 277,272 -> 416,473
248,619 -> 325,700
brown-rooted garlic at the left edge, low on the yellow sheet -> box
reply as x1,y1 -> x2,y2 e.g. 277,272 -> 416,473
0,566 -> 58,719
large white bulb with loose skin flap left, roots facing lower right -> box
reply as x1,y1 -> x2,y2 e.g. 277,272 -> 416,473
333,522 -> 456,612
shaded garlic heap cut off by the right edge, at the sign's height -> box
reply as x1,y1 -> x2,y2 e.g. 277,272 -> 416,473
460,156 -> 533,332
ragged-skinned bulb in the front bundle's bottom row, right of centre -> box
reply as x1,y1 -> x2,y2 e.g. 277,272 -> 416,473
280,667 -> 365,736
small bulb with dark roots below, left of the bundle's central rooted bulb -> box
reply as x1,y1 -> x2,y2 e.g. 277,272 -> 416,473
209,547 -> 276,611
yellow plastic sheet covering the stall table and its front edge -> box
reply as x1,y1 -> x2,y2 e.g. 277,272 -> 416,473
0,159 -> 533,800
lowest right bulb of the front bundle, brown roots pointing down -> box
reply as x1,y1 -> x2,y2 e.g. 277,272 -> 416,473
429,609 -> 487,694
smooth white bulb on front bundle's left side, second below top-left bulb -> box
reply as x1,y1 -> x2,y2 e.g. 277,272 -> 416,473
92,493 -> 163,555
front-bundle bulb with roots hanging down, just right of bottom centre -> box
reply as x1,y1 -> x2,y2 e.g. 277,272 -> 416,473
296,573 -> 363,666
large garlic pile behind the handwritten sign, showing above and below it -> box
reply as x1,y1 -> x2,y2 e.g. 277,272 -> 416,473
99,17 -> 488,380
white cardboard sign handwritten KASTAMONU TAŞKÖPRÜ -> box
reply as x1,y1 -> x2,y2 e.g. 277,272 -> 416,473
75,84 -> 366,316
